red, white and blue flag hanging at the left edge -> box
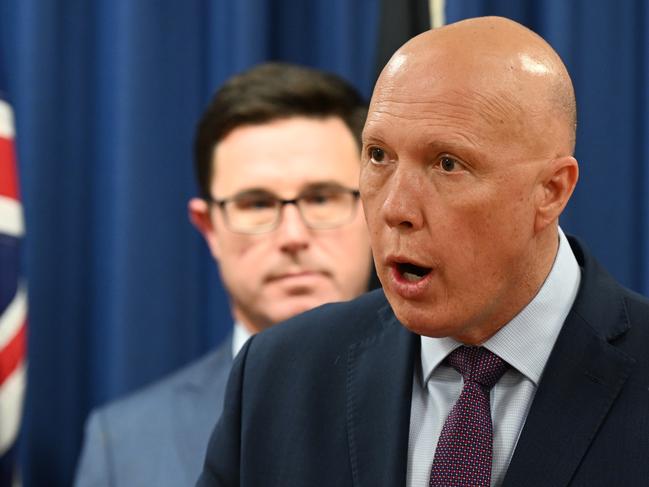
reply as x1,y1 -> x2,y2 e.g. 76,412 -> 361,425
0,92 -> 27,487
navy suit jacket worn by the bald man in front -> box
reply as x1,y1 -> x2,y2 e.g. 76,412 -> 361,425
197,239 -> 649,487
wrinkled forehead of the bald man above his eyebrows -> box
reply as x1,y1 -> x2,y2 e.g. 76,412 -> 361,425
363,64 -> 553,162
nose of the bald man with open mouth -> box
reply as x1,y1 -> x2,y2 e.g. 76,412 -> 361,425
381,167 -> 427,231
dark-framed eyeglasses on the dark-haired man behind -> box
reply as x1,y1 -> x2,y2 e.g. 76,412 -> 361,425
206,185 -> 360,234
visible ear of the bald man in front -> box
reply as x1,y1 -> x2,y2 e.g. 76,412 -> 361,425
534,156 -> 579,232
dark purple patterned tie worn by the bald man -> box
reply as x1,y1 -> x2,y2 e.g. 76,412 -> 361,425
429,346 -> 509,487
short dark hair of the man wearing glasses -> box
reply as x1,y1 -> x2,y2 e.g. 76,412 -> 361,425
194,62 -> 367,198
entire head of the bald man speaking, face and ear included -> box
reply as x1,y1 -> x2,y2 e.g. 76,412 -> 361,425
360,17 -> 579,344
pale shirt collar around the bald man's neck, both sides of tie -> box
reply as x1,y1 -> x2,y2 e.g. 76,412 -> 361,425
421,228 -> 581,386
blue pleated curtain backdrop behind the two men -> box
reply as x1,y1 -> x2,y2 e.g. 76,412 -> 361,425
0,0 -> 649,487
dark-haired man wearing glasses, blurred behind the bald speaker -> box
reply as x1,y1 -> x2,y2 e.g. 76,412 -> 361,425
76,63 -> 372,486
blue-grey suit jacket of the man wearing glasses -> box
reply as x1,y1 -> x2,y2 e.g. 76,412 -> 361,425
75,335 -> 232,487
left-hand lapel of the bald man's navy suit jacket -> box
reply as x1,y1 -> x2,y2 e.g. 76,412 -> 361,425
347,303 -> 419,487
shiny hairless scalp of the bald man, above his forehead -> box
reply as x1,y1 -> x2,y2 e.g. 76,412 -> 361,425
373,17 -> 576,156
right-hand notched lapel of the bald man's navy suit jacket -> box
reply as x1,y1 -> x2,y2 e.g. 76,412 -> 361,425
503,242 -> 634,487
